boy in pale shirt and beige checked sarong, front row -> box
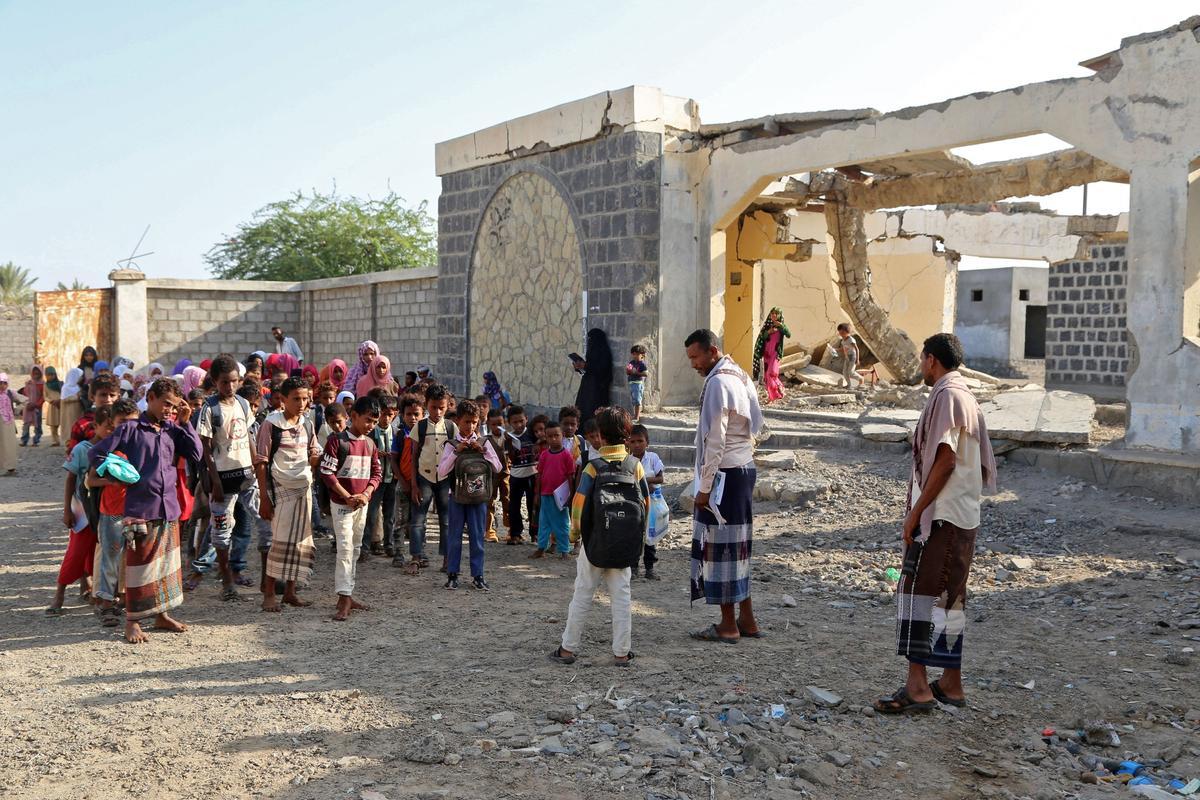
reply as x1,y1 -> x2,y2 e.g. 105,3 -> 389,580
254,378 -> 320,612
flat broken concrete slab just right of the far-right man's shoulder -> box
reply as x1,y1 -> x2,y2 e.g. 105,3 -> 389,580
980,387 -> 1096,444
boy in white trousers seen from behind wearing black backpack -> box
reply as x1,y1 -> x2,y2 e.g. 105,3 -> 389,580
550,407 -> 650,667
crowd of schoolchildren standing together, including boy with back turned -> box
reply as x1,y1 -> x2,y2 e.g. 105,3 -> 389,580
37,354 -> 662,663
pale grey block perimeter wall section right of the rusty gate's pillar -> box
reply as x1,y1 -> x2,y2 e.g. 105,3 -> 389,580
146,287 -> 304,369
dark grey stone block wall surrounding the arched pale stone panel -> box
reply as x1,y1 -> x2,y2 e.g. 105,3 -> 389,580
437,131 -> 662,402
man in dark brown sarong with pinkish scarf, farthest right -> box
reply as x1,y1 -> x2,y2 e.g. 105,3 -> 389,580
875,333 -> 996,714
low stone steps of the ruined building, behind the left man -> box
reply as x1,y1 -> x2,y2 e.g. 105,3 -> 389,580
642,408 -> 908,467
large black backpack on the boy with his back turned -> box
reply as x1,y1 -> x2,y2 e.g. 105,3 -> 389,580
581,456 -> 647,570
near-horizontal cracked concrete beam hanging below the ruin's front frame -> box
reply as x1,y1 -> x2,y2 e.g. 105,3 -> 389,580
810,150 -> 1129,211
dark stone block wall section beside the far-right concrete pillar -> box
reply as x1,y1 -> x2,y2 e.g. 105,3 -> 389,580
1045,245 -> 1129,386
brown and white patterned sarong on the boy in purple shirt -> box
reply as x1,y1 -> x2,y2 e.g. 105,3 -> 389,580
125,519 -> 184,621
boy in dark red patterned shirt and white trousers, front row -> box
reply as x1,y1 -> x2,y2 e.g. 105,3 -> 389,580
320,397 -> 383,622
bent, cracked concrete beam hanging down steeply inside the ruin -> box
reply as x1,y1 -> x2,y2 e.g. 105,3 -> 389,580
824,192 -> 920,384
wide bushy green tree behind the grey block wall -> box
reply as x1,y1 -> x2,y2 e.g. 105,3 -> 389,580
204,192 -> 437,281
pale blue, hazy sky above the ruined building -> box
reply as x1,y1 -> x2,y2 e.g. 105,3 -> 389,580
0,0 -> 1194,290
